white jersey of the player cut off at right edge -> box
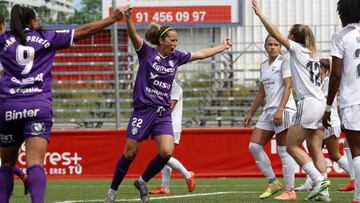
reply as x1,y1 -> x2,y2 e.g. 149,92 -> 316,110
330,23 -> 360,108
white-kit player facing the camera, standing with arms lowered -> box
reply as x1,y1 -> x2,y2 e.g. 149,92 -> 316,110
243,35 -> 296,200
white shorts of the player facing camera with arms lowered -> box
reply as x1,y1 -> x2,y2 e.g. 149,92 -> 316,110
256,108 -> 296,134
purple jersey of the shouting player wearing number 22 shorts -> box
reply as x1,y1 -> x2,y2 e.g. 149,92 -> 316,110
133,42 -> 191,108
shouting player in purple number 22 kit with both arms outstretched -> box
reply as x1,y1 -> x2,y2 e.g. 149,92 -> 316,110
105,5 -> 231,202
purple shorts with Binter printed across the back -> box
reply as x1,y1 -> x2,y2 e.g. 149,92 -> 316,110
0,100 -> 52,147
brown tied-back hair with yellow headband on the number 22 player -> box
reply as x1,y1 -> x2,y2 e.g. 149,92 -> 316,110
145,24 -> 173,46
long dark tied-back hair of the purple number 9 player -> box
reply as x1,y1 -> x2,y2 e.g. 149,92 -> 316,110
10,4 -> 36,45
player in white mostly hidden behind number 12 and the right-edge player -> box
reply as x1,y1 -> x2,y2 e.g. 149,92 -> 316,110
295,59 -> 354,191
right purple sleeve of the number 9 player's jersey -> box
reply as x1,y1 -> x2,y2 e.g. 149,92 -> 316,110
46,30 -> 74,50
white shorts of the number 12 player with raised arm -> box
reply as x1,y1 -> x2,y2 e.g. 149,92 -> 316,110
294,97 -> 325,129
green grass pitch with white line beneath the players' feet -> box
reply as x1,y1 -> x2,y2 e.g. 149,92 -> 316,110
10,178 -> 353,203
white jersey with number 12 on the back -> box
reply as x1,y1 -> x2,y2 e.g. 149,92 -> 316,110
289,40 -> 325,100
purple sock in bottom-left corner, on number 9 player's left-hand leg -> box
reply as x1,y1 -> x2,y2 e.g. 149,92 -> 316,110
0,166 -> 14,203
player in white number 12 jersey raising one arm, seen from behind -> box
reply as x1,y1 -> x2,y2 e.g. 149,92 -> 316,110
252,0 -> 330,200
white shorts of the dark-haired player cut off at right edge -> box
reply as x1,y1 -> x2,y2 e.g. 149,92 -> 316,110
340,105 -> 360,131
